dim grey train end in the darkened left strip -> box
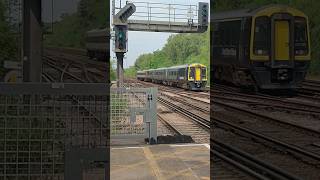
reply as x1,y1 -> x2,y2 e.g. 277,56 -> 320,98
86,28 -> 110,61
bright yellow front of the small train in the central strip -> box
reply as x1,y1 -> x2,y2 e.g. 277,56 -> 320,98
187,63 -> 208,90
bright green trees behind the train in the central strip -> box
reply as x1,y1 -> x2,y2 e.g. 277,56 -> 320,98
125,30 -> 210,77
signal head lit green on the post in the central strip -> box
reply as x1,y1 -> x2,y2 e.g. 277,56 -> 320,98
114,25 -> 128,53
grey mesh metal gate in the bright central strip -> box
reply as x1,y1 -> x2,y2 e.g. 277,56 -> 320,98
110,88 -> 157,140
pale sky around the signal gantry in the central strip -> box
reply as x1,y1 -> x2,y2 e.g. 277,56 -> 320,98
110,0 -> 210,68
